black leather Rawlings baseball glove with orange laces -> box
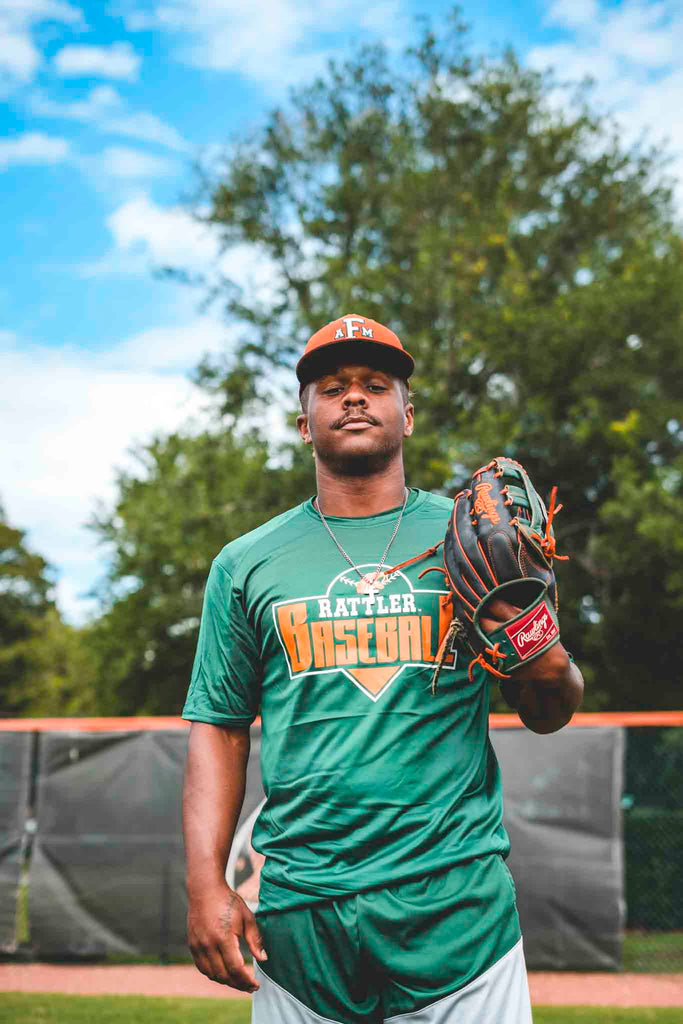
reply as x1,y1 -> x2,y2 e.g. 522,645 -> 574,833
432,458 -> 565,693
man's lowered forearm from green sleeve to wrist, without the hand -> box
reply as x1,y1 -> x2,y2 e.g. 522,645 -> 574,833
182,722 -> 250,896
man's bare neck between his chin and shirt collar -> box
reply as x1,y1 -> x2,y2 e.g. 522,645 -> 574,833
315,460 -> 405,517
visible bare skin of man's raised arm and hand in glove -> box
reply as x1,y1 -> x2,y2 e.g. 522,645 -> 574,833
481,598 -> 584,733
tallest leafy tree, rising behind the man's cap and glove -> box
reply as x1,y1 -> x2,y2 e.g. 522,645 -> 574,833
179,13 -> 683,708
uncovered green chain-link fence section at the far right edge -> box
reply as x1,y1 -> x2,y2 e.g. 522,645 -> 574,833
622,727 -> 683,972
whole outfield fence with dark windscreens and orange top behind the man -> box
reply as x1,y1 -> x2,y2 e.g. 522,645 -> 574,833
0,712 -> 683,971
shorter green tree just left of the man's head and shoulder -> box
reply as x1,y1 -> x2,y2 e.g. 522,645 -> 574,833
89,429 -> 312,715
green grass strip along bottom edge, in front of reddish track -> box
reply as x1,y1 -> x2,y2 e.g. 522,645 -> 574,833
0,992 -> 681,1024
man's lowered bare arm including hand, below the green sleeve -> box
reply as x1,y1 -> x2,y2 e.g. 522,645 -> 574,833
182,722 -> 267,992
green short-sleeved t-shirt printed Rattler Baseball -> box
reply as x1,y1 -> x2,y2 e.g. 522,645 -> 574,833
183,490 -> 508,910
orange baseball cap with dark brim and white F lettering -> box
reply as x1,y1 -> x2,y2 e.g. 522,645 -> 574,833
296,313 -> 415,389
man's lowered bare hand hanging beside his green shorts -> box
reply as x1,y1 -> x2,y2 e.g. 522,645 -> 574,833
187,885 -> 268,992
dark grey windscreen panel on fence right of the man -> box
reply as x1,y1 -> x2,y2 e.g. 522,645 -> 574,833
492,728 -> 625,971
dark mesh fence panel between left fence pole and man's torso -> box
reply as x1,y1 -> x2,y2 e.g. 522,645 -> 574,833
29,730 -> 261,957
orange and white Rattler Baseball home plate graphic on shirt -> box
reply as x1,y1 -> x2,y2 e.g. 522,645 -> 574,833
272,563 -> 457,700
